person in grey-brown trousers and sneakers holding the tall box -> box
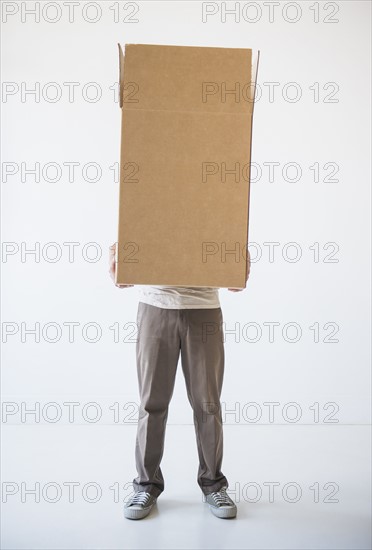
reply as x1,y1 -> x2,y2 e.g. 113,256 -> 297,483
109,244 -> 251,519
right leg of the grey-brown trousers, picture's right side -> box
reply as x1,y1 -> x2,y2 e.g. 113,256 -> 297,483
181,308 -> 229,494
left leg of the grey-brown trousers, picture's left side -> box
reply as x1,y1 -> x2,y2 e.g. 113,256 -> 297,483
133,302 -> 180,496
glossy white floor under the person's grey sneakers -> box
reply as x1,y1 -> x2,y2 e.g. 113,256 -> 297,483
2,424 -> 371,550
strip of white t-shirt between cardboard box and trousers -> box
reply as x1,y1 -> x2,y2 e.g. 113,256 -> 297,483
136,285 -> 220,309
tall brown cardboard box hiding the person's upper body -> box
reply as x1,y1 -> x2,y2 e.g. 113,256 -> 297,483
116,44 -> 259,288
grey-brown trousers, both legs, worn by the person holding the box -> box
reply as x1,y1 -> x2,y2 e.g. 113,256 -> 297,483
133,302 -> 229,496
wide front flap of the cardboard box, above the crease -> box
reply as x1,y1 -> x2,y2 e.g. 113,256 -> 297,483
123,44 -> 253,114
